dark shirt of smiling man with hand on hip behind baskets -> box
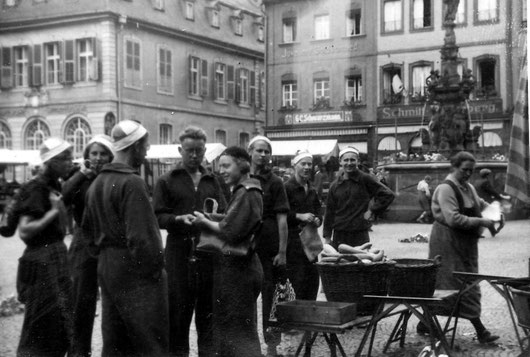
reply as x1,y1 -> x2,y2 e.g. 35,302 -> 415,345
323,171 -> 394,238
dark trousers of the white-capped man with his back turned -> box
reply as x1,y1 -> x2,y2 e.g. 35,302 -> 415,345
98,248 -> 169,357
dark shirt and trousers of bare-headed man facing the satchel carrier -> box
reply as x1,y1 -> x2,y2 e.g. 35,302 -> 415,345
153,164 -> 226,357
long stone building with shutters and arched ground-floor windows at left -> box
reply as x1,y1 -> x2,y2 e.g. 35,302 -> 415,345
0,0 -> 265,157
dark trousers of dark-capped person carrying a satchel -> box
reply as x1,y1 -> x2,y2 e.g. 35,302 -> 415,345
213,254 -> 263,357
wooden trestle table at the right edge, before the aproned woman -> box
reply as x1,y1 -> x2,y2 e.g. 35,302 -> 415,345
449,271 -> 530,349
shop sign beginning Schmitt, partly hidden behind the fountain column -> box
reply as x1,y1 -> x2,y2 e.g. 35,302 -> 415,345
377,99 -> 502,119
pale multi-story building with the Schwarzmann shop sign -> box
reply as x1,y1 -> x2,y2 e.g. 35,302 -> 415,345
264,0 -> 377,161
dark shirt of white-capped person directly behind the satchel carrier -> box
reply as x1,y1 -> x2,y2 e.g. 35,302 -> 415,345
251,171 -> 289,257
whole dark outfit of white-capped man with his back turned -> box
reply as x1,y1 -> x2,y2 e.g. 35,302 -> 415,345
83,163 -> 169,356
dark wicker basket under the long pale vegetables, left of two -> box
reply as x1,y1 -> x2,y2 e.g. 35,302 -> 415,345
315,261 -> 395,315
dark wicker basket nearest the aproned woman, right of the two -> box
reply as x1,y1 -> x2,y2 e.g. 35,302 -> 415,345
388,257 -> 441,297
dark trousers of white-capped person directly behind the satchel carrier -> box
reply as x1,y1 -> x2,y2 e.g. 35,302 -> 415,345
259,250 -> 289,346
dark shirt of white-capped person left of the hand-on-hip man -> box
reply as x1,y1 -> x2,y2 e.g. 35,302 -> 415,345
285,177 -> 322,232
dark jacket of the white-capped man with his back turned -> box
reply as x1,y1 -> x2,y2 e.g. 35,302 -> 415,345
82,163 -> 164,274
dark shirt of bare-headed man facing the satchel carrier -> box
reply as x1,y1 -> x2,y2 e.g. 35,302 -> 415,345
153,164 -> 226,238
